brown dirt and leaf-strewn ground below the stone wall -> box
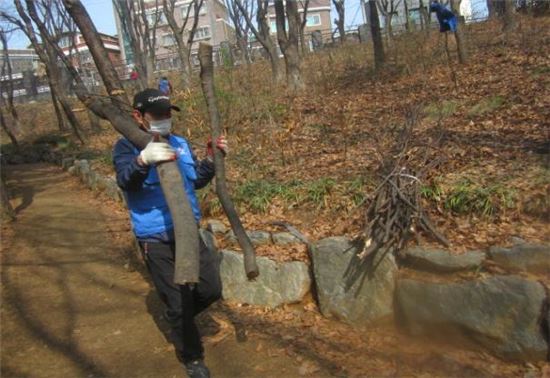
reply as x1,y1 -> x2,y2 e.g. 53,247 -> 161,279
0,164 -> 550,378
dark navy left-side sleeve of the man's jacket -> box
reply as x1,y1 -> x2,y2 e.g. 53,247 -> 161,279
113,139 -> 149,191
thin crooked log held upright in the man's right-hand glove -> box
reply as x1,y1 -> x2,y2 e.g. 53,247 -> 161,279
199,43 -> 259,280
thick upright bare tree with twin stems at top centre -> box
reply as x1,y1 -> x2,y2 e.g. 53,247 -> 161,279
274,0 -> 305,91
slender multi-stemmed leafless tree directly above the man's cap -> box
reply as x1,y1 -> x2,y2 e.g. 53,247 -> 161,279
113,0 -> 161,89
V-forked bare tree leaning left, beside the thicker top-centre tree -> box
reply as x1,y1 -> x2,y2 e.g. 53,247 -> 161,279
234,0 -> 283,83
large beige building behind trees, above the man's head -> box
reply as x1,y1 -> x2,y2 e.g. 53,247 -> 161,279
114,0 -> 235,70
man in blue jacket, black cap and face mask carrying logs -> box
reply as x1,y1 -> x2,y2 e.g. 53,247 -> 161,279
113,89 -> 227,378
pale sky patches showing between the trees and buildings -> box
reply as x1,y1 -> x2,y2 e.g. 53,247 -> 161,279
4,0 -> 486,48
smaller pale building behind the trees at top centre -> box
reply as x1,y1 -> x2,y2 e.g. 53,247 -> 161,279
267,0 -> 333,49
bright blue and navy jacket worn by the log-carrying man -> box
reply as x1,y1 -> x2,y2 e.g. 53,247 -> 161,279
113,135 -> 214,241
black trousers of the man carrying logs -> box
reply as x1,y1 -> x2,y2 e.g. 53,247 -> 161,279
140,238 -> 222,362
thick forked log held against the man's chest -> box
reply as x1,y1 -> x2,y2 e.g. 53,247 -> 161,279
63,0 -> 199,285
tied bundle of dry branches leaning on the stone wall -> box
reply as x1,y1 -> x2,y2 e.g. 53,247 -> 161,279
358,108 -> 449,260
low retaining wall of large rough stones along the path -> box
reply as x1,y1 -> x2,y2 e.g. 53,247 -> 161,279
61,159 -> 550,361
